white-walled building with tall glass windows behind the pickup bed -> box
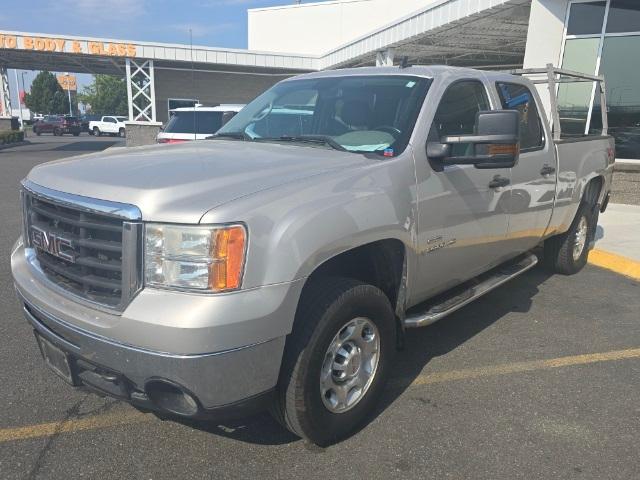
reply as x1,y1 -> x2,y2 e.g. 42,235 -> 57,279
524,0 -> 640,161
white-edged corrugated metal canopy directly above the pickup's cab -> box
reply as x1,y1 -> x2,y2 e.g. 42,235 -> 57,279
320,0 -> 531,69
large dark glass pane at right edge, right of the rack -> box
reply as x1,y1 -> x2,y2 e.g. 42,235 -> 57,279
591,36 -> 640,159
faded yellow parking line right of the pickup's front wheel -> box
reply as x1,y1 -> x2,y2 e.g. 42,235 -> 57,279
392,348 -> 640,387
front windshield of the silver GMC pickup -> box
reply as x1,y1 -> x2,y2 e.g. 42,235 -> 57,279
218,75 -> 431,156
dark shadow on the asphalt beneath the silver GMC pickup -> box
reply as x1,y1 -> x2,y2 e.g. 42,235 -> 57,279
166,267 -> 551,449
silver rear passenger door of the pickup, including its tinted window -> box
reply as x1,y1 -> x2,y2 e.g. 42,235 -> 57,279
496,82 -> 556,253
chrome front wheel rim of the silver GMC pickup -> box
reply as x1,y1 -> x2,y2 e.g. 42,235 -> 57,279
320,317 -> 380,413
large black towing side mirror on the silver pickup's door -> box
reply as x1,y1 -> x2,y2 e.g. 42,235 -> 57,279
427,110 -> 520,168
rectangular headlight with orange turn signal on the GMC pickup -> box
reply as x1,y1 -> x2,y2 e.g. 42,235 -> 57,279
144,223 -> 247,292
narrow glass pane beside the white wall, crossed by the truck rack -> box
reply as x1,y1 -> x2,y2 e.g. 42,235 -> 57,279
558,38 -> 600,136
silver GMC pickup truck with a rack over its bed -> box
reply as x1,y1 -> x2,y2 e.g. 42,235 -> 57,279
11,66 -> 614,445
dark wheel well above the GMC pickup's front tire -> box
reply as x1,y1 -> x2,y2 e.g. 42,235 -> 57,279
307,239 -> 405,310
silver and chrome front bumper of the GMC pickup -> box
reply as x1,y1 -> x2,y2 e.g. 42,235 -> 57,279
12,245 -> 297,417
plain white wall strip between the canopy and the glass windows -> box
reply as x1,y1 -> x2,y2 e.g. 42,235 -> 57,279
524,0 -> 569,116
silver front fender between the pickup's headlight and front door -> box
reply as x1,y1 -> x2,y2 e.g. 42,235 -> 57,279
201,157 -> 415,288
